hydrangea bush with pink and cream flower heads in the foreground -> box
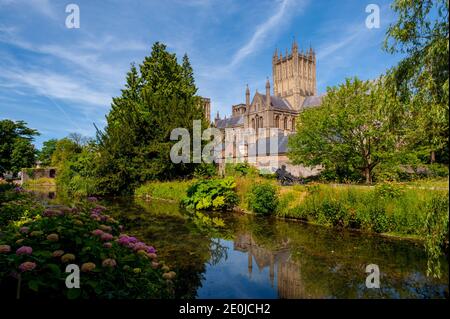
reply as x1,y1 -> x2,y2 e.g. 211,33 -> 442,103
0,195 -> 175,299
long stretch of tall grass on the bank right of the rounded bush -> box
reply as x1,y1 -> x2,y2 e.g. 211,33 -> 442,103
276,185 -> 448,238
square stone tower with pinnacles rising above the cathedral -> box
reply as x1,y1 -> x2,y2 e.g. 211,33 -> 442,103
272,40 -> 317,111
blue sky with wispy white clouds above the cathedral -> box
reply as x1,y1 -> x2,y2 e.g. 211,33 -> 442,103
0,0 -> 399,147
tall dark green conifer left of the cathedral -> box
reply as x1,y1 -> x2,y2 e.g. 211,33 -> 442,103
96,42 -> 206,194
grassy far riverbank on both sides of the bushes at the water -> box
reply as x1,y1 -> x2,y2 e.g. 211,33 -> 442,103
135,177 -> 448,245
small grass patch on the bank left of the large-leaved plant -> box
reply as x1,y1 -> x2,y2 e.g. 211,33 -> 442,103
134,180 -> 194,202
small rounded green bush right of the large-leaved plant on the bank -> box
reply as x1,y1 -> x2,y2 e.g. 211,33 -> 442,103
248,183 -> 278,215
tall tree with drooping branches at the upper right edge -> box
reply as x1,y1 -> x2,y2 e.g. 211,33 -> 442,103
384,0 -> 449,162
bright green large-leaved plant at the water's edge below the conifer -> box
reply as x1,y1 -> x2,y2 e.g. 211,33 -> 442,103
181,177 -> 239,210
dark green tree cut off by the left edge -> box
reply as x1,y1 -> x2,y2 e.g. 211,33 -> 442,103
0,120 -> 39,173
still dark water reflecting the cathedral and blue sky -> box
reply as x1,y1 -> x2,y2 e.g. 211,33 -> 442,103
31,189 -> 448,298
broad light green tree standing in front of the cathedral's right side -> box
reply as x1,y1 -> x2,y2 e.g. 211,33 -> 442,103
289,79 -> 403,183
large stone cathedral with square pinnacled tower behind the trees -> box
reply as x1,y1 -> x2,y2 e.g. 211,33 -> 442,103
214,40 -> 322,177
